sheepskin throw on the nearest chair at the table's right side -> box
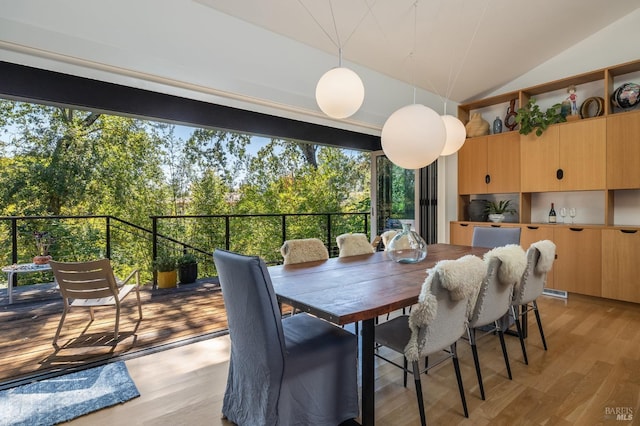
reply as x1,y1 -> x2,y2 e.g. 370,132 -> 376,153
404,255 -> 487,361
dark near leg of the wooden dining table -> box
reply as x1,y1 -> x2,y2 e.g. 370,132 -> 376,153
360,318 -> 375,426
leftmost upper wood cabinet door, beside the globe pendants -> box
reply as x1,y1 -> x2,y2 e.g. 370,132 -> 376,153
458,136 -> 487,194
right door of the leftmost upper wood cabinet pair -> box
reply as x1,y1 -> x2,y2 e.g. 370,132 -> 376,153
487,132 -> 520,194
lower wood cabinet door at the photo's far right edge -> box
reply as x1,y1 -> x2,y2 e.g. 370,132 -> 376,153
602,228 -> 640,303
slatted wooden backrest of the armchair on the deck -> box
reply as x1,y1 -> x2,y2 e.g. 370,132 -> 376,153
49,259 -> 118,303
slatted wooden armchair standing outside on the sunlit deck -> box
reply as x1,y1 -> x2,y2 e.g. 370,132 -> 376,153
49,259 -> 142,347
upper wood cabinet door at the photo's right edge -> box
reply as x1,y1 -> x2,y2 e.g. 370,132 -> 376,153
607,112 -> 640,189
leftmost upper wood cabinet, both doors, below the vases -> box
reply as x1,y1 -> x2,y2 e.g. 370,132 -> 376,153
458,132 -> 520,194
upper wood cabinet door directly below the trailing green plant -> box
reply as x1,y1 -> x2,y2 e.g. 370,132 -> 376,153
520,125 -> 560,192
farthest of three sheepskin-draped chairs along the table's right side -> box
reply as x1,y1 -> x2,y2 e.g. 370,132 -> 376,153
511,240 -> 556,364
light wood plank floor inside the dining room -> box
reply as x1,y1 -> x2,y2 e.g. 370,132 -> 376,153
71,295 -> 640,426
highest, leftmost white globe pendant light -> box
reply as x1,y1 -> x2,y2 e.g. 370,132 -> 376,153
316,67 -> 364,118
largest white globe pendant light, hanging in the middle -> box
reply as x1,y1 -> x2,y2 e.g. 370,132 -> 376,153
381,104 -> 447,169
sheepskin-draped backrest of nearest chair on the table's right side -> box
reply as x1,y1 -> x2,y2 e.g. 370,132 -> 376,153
405,255 -> 486,360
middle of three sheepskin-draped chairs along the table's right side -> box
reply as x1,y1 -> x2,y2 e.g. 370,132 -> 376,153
467,244 -> 526,400
